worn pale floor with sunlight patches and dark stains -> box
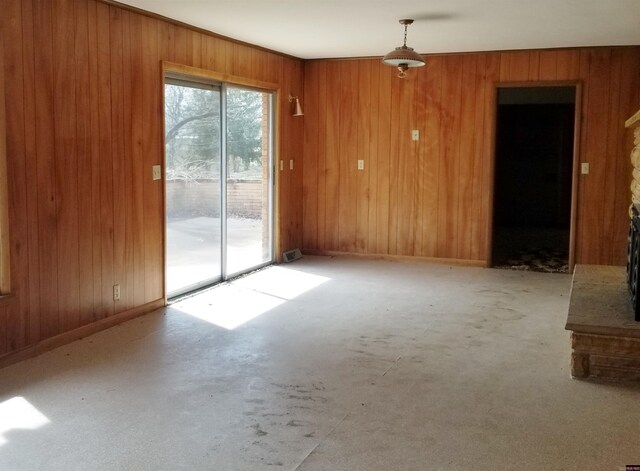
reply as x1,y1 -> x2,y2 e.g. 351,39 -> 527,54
0,257 -> 640,471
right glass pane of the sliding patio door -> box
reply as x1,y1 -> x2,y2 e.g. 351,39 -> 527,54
226,86 -> 273,275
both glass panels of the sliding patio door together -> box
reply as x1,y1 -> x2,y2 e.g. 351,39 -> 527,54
165,77 -> 273,297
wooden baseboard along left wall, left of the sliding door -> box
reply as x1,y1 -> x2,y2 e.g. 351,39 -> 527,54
0,299 -> 165,368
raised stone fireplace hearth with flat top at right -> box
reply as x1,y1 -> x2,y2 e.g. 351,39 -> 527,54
565,265 -> 640,381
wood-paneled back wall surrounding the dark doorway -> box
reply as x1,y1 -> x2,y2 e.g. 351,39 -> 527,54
303,47 -> 640,265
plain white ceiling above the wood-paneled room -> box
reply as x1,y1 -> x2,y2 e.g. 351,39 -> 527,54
120,0 -> 640,59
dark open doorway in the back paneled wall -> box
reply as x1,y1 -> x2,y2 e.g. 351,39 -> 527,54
492,87 -> 576,272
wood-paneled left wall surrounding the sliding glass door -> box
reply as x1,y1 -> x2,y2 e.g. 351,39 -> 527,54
0,0 -> 303,360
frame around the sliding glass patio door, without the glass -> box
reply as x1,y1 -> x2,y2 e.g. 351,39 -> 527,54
161,61 -> 280,305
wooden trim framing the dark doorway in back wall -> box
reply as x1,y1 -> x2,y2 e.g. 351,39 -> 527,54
486,80 -> 583,273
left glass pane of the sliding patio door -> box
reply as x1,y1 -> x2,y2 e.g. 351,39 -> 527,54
165,79 -> 222,297
